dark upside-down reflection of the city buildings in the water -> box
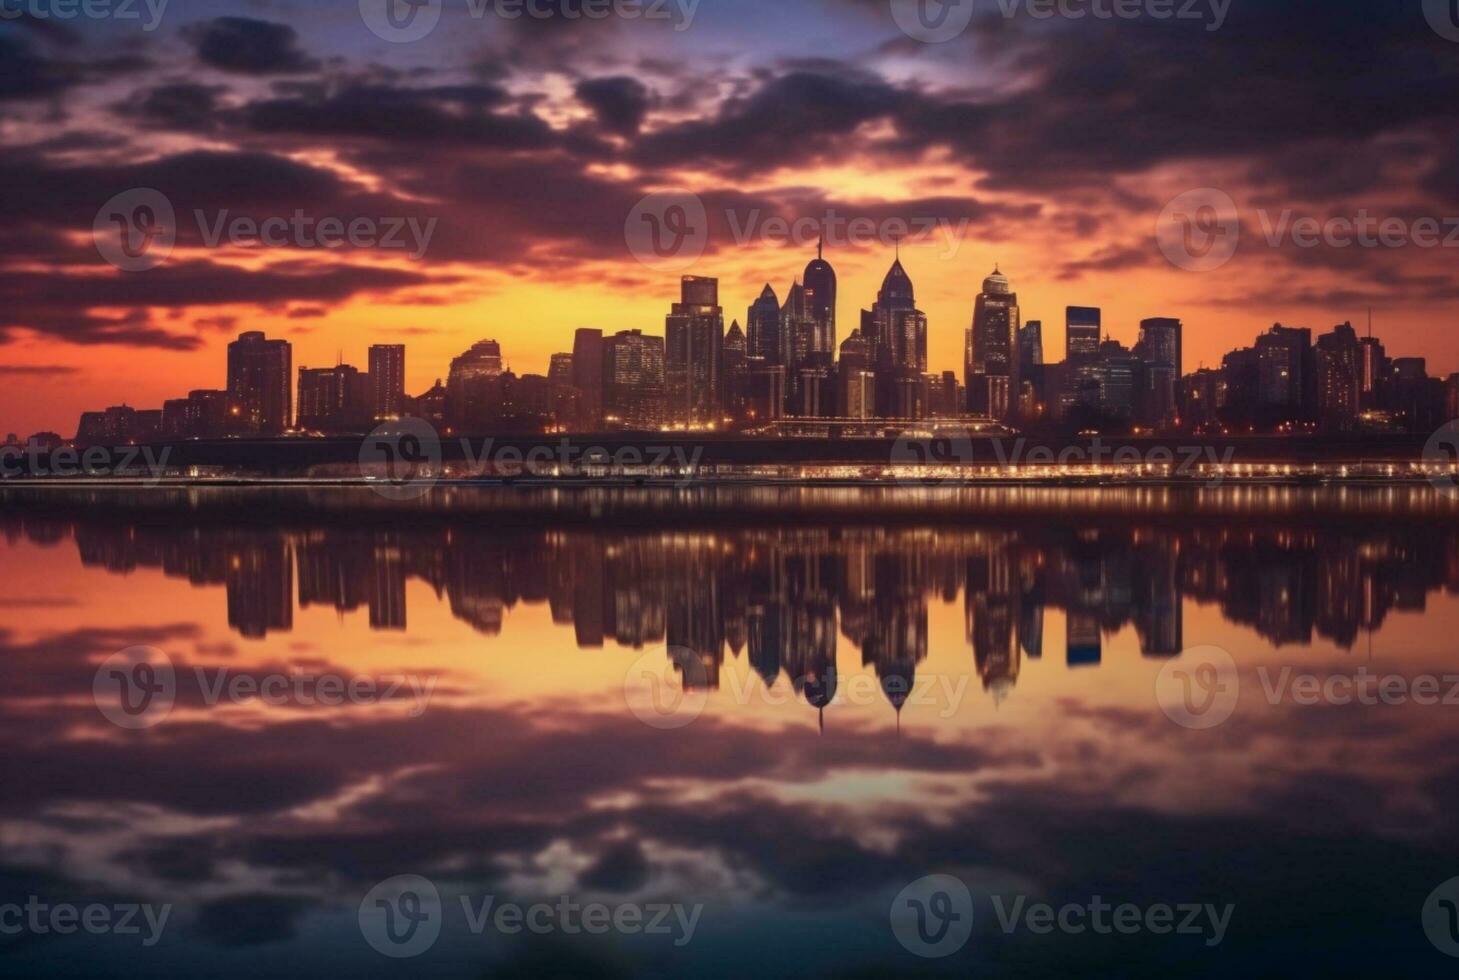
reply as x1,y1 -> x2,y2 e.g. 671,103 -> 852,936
3,518 -> 1459,697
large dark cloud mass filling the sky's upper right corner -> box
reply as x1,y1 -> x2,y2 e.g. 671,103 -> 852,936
881,0 -> 1459,194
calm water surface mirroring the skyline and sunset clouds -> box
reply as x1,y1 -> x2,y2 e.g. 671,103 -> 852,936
0,489 -> 1459,977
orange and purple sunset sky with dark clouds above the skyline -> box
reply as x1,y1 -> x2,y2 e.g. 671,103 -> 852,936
0,0 -> 1459,436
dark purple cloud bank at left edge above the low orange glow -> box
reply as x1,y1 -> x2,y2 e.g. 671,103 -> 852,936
0,143 -> 452,350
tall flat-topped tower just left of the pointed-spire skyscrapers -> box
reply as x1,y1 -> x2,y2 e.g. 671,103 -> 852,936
664,276 -> 725,426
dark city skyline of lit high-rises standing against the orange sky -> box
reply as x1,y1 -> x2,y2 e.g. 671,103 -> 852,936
31,241 -> 1459,445
